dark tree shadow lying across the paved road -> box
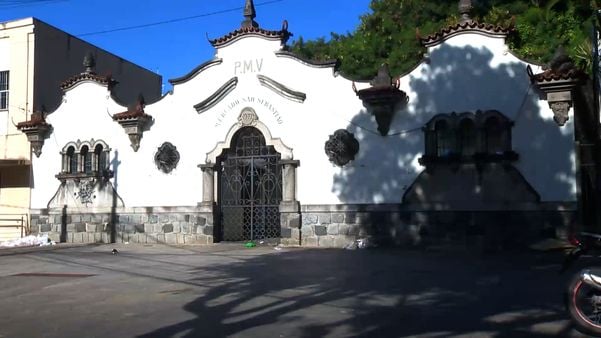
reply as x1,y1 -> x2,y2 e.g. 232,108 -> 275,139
131,249 -> 571,337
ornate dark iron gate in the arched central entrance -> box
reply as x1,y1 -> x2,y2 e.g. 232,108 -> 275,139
219,127 -> 282,241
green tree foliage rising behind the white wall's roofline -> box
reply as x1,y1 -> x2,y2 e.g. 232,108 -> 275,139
290,0 -> 597,79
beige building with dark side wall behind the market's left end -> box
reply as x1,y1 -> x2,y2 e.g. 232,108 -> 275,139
0,18 -> 161,241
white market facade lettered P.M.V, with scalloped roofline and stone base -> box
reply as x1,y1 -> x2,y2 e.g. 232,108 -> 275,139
24,1 -> 576,247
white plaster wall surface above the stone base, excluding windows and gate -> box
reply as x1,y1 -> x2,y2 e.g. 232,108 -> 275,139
32,34 -> 575,208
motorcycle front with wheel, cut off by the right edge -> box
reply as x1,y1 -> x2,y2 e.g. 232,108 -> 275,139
561,232 -> 601,337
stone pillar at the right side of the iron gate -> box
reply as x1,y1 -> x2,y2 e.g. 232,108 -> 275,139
279,160 -> 301,245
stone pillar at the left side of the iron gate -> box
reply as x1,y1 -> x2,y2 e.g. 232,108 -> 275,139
198,163 -> 219,243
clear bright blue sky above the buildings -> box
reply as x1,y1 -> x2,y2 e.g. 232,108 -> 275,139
0,0 -> 370,90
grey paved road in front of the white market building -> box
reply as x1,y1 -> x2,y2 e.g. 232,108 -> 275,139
0,244 -> 592,338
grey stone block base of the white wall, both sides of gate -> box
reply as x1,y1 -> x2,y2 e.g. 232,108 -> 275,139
31,204 -> 576,250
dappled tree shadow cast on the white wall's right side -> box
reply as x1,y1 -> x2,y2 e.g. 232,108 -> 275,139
332,44 -> 576,248
